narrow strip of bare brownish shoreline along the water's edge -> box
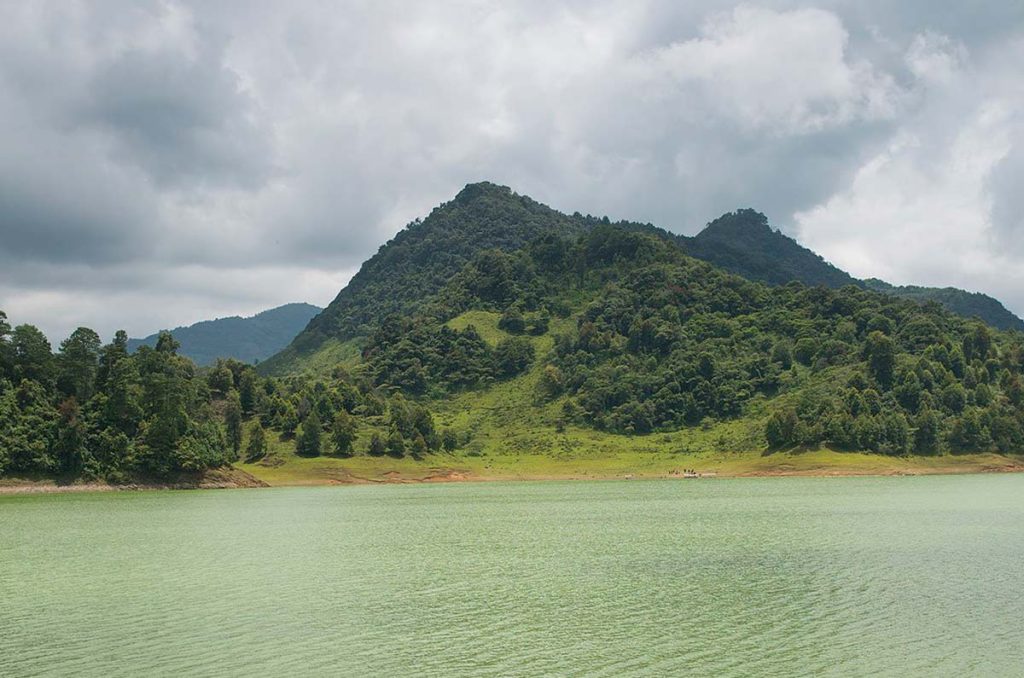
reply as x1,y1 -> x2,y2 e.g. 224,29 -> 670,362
0,455 -> 1024,496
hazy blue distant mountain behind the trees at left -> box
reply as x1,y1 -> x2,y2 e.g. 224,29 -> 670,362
128,303 -> 321,366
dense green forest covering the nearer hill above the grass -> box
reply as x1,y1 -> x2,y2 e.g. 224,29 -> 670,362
352,226 -> 1024,454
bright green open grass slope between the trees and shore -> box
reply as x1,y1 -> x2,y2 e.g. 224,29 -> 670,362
239,311 -> 1024,485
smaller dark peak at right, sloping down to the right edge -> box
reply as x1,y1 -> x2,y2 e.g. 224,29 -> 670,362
677,209 -> 1024,330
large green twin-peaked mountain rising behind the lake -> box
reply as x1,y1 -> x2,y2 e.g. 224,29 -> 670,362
245,184 -> 1024,464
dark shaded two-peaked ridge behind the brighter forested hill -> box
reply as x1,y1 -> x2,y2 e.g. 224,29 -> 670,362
260,181 -> 1024,374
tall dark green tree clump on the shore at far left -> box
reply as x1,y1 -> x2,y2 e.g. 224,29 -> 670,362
0,313 -> 230,481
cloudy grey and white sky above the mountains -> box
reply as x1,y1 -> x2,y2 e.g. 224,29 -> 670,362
0,0 -> 1024,343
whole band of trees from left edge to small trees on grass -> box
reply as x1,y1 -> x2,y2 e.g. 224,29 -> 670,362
0,311 -> 450,482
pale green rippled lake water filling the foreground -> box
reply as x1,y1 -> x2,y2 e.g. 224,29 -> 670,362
0,475 -> 1024,676
